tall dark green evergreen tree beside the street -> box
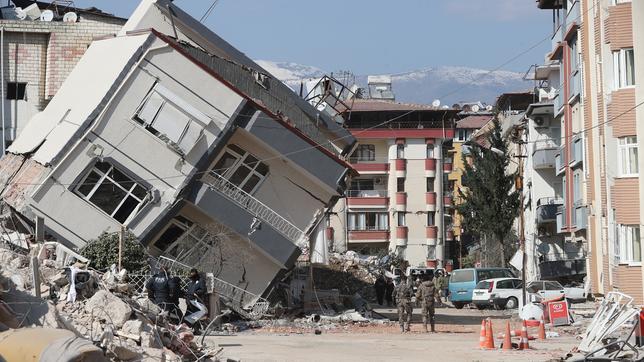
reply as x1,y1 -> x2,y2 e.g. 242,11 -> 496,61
457,118 -> 520,266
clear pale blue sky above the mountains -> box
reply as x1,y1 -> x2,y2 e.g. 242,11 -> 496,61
74,0 -> 551,74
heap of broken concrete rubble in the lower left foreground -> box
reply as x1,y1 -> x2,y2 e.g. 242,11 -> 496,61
0,248 -> 224,361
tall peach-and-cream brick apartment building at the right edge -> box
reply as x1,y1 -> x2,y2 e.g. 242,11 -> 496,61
538,0 -> 644,304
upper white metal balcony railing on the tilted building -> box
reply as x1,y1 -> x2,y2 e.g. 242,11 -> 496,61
202,172 -> 306,246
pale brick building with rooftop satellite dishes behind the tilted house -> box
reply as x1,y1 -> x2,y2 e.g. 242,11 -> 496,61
0,0 -> 126,154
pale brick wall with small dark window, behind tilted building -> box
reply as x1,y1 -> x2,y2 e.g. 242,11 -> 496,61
0,14 -> 125,139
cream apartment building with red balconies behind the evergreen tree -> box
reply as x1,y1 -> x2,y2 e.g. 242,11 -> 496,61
327,99 -> 459,267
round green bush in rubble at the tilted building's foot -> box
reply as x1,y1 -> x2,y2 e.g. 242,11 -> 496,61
80,232 -> 150,273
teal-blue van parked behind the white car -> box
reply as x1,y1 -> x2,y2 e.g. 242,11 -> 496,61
449,268 -> 516,309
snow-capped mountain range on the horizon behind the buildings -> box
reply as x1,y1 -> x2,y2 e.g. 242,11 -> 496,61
257,60 -> 534,105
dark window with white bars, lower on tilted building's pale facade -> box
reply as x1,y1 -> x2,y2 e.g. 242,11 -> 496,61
76,162 -> 148,224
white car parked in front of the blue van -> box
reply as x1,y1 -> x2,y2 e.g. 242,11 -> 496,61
472,278 -> 522,309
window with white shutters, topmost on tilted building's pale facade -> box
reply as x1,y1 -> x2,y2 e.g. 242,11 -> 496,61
134,85 -> 210,154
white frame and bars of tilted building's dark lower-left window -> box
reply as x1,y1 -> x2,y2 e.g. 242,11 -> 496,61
73,161 -> 150,225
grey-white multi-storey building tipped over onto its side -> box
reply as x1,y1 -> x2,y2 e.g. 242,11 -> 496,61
0,0 -> 355,304
